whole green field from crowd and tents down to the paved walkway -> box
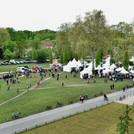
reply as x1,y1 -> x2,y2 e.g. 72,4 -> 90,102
0,69 -> 132,122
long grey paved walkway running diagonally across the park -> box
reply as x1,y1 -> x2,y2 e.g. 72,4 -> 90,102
0,88 -> 134,134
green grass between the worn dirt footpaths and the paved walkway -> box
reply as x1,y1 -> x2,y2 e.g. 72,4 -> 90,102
0,76 -> 130,122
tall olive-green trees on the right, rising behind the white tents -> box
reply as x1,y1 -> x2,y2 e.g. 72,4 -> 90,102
56,10 -> 134,69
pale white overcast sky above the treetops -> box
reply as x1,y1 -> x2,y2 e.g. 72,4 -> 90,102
0,0 -> 134,31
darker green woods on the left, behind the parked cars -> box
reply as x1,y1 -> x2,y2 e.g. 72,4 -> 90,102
0,28 -> 56,61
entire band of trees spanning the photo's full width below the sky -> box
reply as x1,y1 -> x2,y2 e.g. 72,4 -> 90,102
0,10 -> 134,68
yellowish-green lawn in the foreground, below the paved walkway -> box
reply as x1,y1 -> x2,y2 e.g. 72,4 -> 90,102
20,103 -> 134,134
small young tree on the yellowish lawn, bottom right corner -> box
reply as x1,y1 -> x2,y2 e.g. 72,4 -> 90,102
116,105 -> 133,134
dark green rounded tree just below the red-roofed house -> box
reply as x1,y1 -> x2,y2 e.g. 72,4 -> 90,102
37,48 -> 49,62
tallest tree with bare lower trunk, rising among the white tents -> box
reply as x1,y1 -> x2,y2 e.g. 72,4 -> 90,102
84,10 -> 109,72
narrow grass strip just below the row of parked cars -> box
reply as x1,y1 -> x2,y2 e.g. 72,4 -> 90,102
0,63 -> 50,72
